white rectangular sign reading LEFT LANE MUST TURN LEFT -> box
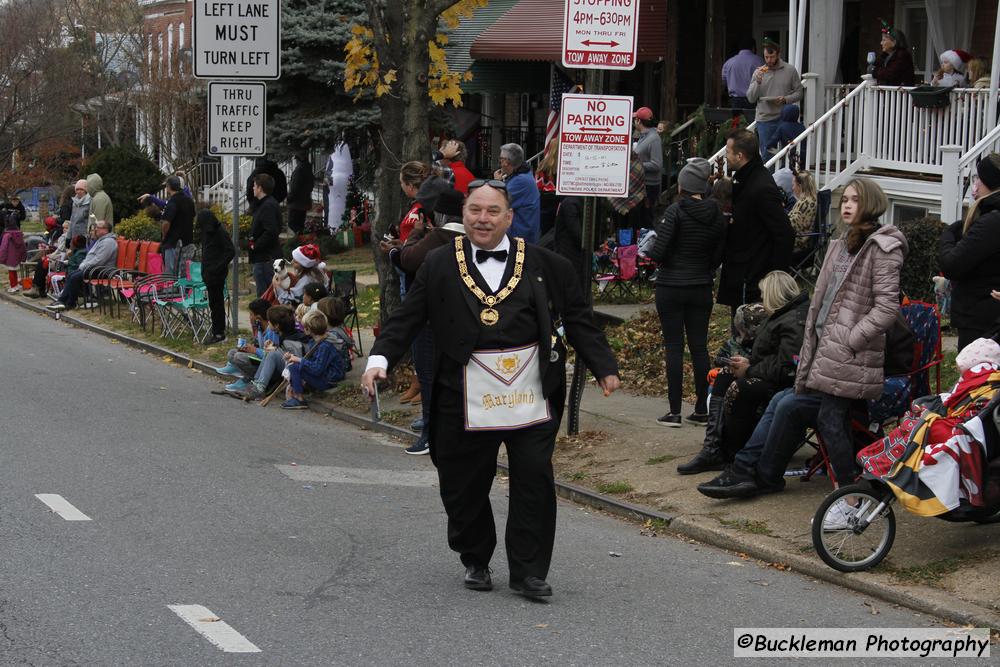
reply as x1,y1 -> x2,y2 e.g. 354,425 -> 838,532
192,0 -> 281,80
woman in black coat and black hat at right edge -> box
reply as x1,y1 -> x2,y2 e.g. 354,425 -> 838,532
938,153 -> 1000,352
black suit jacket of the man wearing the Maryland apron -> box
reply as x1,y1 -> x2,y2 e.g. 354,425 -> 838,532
371,240 -> 618,397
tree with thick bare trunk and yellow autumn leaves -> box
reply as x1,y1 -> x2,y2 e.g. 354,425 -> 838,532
344,0 -> 487,319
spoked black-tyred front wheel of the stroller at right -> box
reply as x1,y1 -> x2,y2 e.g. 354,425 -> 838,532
812,483 -> 896,572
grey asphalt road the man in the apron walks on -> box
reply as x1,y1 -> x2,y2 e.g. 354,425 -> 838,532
0,302 -> 934,665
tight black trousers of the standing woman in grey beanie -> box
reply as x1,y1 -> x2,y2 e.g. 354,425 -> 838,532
656,285 -> 712,415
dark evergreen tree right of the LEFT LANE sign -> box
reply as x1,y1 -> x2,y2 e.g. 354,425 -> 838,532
267,0 -> 379,159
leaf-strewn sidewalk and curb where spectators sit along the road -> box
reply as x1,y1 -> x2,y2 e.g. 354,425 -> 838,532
0,294 -> 1000,628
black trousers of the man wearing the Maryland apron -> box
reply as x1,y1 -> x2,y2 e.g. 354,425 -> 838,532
431,383 -> 565,581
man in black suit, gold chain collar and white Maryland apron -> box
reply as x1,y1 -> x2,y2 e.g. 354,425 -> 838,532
361,181 -> 619,597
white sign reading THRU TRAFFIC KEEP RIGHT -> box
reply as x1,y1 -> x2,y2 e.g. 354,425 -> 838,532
208,81 -> 267,157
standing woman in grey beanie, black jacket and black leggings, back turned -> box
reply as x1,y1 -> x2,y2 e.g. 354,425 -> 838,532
649,158 -> 726,427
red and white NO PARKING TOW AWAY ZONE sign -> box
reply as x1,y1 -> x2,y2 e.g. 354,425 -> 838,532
556,94 -> 632,197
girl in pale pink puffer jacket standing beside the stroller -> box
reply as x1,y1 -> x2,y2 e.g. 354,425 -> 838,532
795,178 -> 908,484
